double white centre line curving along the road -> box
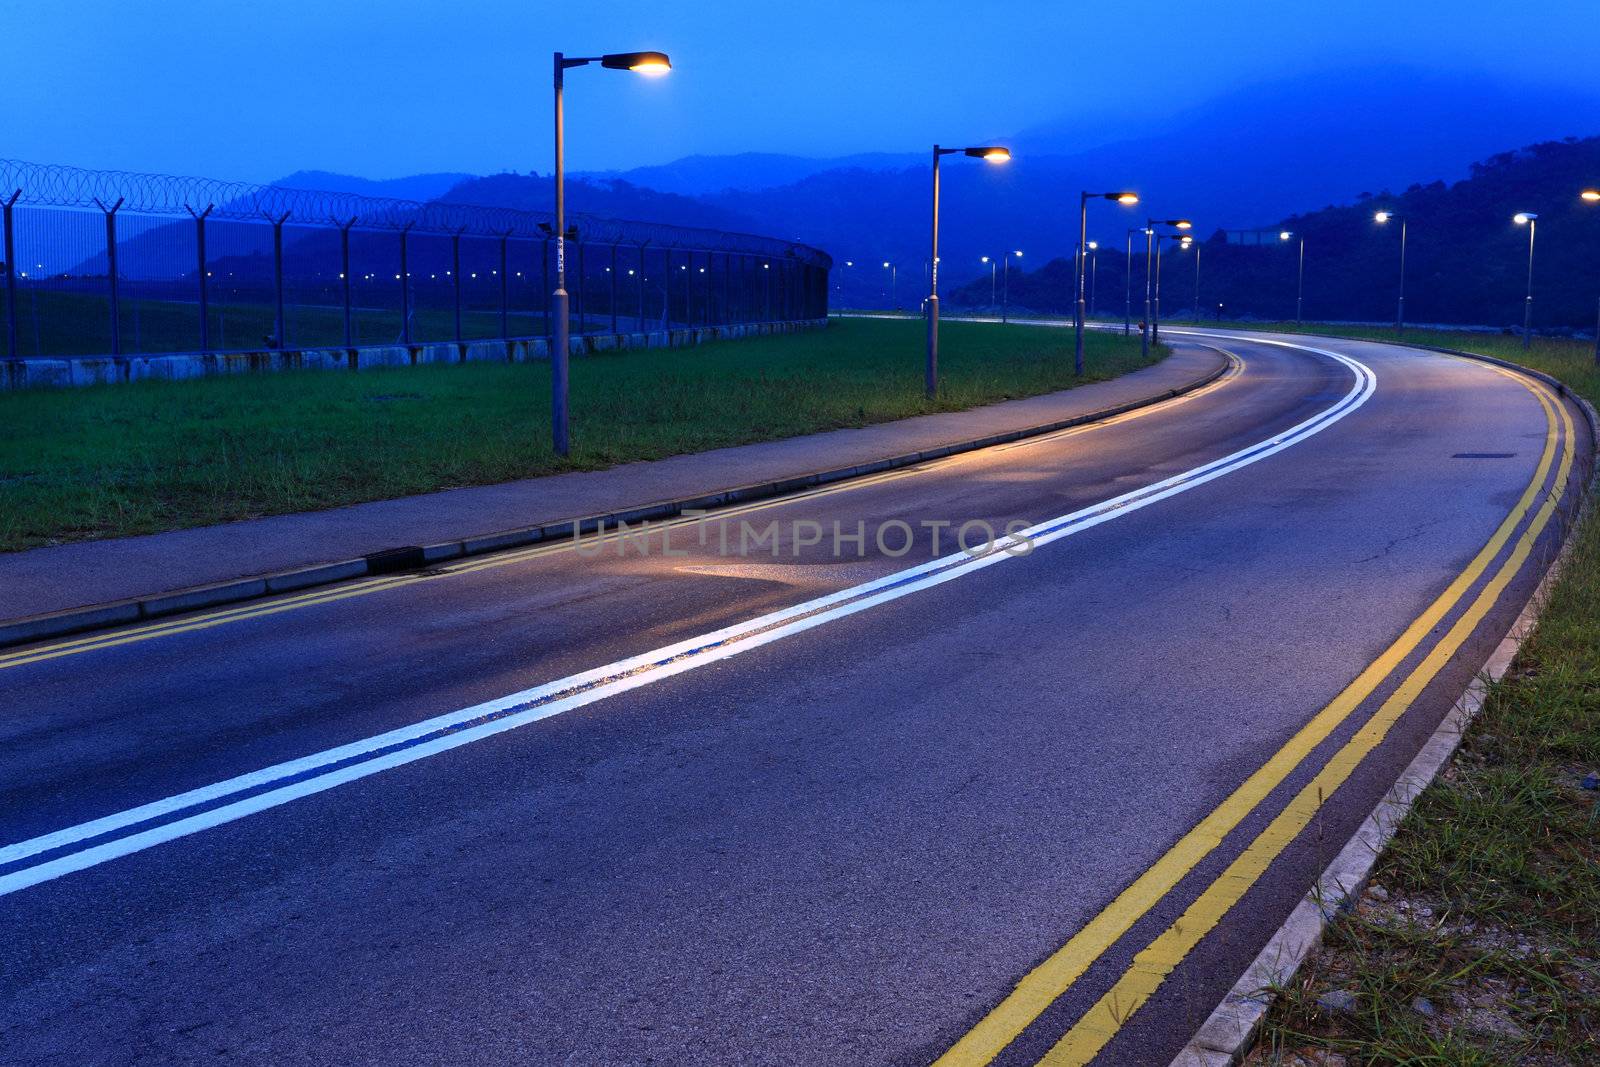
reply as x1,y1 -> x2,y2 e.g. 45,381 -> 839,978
0,339 -> 1378,896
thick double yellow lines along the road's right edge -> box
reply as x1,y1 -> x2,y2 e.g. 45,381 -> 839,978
936,368 -> 1573,1067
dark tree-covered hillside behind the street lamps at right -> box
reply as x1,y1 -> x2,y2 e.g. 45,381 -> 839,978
947,138 -> 1600,330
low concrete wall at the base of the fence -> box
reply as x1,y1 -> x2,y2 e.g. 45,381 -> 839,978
0,318 -> 827,396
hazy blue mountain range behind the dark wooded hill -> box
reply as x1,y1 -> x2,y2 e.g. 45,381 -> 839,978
646,67 -> 1600,299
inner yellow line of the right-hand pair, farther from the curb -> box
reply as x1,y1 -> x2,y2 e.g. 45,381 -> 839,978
934,374 -> 1570,1067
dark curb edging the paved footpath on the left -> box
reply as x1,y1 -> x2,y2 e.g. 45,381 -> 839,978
0,342 -> 1232,648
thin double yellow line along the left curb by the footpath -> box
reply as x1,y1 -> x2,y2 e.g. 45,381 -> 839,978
0,349 -> 1243,670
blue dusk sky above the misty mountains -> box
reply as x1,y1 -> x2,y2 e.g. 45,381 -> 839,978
12,0 -> 1600,181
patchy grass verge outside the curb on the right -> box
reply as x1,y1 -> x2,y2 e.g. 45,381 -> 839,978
1246,326 -> 1600,1067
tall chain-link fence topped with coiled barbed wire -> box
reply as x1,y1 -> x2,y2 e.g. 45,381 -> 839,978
0,160 -> 832,358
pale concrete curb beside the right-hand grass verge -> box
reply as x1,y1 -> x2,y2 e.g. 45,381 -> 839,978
1170,334 -> 1600,1067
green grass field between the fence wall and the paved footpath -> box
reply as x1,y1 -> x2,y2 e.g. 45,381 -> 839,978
0,320 -> 1164,552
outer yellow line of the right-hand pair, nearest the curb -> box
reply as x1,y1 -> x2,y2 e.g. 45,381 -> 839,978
1040,379 -> 1573,1067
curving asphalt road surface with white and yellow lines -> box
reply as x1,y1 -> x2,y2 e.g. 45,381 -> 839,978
0,334 -> 1592,1065
